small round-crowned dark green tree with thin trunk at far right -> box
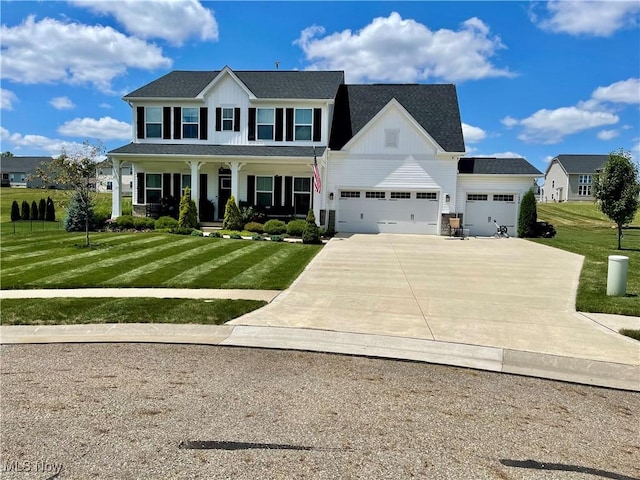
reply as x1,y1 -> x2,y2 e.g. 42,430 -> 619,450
593,149 -> 640,250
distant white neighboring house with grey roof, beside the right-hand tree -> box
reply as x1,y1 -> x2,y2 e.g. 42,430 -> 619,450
541,155 -> 609,202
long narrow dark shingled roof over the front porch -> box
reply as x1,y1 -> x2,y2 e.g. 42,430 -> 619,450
108,143 -> 325,158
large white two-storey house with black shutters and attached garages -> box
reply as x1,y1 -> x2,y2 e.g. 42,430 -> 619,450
108,67 -> 542,235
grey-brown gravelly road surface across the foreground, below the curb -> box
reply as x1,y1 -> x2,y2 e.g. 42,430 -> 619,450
0,344 -> 640,480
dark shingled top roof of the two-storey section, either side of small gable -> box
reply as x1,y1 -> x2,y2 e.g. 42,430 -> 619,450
124,70 -> 344,100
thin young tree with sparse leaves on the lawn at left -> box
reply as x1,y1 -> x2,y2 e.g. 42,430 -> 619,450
36,142 -> 104,246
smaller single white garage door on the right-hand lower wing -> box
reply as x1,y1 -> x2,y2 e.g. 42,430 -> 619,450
464,193 -> 518,236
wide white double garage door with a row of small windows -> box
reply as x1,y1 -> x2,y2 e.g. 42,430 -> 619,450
337,190 -> 440,235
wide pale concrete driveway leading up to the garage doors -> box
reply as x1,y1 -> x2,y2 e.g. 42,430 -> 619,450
230,234 -> 640,365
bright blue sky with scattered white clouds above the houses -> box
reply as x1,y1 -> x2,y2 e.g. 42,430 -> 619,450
0,0 -> 640,171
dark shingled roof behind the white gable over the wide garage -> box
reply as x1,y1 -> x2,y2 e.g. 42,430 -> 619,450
329,84 -> 465,152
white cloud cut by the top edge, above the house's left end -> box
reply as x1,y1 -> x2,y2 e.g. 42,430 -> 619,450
72,0 -> 218,46
